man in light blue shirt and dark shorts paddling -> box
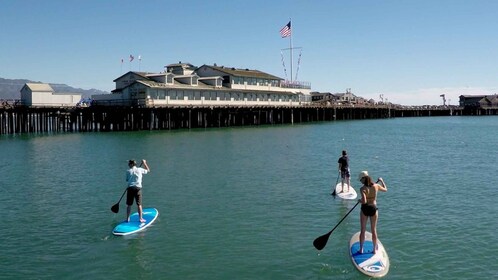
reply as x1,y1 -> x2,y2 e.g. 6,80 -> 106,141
126,159 -> 150,223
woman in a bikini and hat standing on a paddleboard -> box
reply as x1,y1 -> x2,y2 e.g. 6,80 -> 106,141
358,171 -> 387,254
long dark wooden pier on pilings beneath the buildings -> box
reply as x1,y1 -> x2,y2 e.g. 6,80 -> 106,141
0,106 -> 498,134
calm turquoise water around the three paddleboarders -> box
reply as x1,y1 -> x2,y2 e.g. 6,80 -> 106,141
0,117 -> 498,279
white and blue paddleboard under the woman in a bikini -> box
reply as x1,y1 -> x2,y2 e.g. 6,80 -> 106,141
349,231 -> 389,277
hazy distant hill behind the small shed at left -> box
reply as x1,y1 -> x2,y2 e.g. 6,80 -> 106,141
0,78 -> 109,99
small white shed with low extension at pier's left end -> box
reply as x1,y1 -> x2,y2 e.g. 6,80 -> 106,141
21,83 -> 81,107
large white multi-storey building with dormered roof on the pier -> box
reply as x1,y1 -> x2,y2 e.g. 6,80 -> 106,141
92,62 -> 311,107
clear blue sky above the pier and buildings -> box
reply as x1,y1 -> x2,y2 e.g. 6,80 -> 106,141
0,0 -> 498,105
